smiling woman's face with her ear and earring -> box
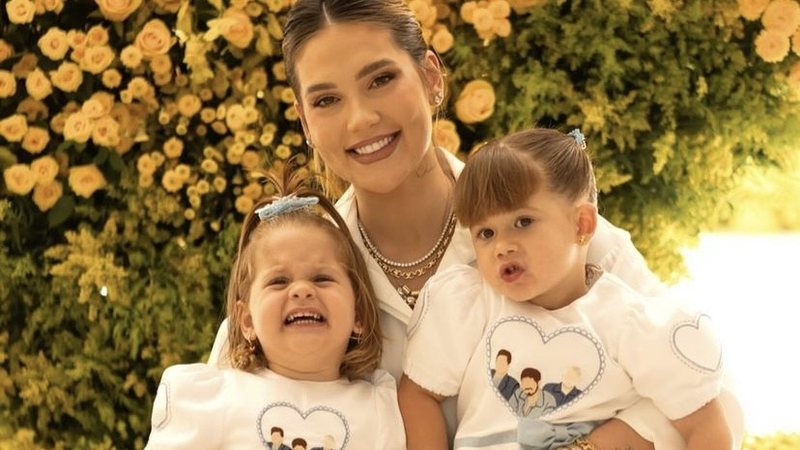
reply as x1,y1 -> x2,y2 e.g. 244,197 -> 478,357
295,23 -> 442,193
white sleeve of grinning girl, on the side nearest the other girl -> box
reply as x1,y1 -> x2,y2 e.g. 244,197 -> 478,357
372,370 -> 406,450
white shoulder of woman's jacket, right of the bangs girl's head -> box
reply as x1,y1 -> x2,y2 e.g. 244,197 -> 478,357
587,216 -> 666,295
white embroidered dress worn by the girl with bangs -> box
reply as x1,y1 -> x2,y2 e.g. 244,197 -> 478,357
404,265 -> 722,449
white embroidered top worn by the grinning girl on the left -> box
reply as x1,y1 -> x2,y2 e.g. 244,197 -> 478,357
145,364 -> 405,450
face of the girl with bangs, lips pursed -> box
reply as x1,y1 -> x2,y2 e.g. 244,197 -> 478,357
470,189 -> 586,309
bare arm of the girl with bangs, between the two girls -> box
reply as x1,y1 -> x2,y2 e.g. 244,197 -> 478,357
398,375 -> 448,450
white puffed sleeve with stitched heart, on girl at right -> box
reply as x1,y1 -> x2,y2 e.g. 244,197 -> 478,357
617,299 -> 723,420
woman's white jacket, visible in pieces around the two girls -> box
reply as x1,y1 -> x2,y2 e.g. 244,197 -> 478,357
208,152 -> 744,448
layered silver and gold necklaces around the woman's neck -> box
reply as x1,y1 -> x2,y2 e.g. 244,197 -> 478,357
358,205 -> 456,309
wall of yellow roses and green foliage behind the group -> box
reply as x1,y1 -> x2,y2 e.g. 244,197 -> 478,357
0,0 -> 800,449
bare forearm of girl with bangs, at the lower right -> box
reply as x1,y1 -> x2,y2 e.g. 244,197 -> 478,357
672,398 -> 733,450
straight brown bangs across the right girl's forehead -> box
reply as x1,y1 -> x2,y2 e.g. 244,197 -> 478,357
455,144 -> 541,227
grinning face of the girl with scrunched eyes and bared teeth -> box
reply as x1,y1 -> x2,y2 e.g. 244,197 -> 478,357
242,221 -> 358,380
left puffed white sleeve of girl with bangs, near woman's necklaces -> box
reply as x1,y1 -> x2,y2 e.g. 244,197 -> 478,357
403,265 -> 486,397
